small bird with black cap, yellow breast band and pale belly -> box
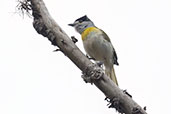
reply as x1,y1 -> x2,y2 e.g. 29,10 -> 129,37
69,15 -> 119,85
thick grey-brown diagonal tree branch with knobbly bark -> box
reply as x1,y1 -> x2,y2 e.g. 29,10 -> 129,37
20,0 -> 147,114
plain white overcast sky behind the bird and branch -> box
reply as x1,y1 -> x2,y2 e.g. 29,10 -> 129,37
0,0 -> 171,114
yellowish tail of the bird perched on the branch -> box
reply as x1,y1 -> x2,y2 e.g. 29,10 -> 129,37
105,67 -> 119,86
